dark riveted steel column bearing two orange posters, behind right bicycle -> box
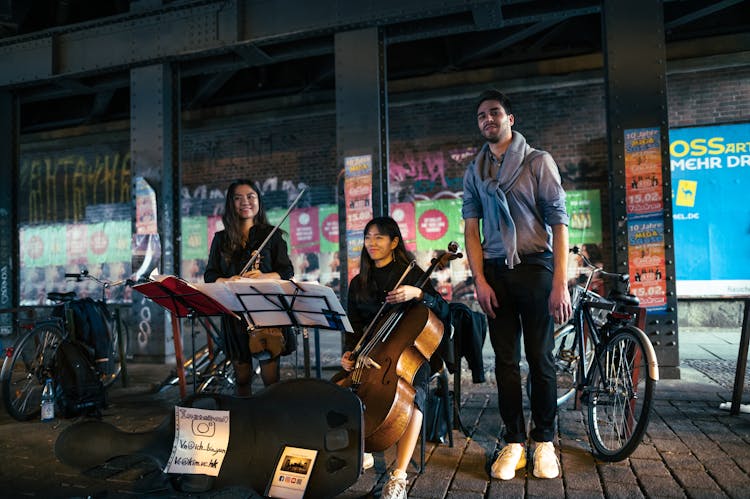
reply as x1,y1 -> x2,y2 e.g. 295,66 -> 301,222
602,0 -> 680,378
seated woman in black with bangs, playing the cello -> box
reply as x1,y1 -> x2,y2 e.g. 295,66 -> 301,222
341,217 -> 449,499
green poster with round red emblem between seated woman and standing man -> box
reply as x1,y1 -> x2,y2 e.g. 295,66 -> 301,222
415,199 -> 463,251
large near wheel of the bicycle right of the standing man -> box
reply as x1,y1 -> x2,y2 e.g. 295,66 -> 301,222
585,326 -> 656,462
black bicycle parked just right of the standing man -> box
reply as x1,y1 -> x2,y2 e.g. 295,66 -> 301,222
553,247 -> 659,462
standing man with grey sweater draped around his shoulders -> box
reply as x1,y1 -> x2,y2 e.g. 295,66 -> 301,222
462,90 -> 572,480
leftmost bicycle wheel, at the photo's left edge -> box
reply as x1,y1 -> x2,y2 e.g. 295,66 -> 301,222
1,323 -> 63,421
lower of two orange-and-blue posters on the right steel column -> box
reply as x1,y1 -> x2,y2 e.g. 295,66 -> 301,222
628,218 -> 667,310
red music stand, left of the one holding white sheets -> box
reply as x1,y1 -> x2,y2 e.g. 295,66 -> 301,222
133,275 -> 239,398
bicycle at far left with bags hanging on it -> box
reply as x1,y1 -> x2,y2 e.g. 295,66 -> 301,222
0,269 -> 126,421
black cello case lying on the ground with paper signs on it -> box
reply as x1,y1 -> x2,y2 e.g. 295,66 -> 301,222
55,379 -> 364,498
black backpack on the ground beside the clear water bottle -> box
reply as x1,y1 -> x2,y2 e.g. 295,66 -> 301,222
55,339 -> 106,418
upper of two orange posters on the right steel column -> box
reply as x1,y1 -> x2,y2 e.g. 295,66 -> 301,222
625,128 -> 664,214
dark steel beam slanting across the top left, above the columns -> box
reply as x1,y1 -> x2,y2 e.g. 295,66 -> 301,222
0,0 -> 506,87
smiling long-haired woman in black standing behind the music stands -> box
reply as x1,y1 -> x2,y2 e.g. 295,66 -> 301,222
203,180 -> 294,395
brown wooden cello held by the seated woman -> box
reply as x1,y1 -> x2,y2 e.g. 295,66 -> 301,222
339,242 -> 463,452
